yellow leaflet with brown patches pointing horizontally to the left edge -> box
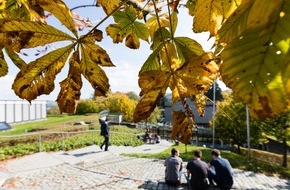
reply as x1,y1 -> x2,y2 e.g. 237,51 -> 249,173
0,20 -> 75,51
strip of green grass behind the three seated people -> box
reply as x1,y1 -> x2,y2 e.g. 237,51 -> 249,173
124,144 -> 290,179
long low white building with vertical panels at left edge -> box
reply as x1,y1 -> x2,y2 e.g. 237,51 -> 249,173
0,100 -> 47,124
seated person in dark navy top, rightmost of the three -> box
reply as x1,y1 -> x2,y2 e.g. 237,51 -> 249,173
208,149 -> 234,189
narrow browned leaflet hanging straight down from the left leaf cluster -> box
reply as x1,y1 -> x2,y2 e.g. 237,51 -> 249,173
56,51 -> 83,113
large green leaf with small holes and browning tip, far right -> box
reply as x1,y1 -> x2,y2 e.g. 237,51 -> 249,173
221,25 -> 290,118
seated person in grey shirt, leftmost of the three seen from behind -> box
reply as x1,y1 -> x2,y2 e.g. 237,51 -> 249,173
164,148 -> 183,185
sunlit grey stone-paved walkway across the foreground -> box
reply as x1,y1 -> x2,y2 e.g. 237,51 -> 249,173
0,140 -> 290,190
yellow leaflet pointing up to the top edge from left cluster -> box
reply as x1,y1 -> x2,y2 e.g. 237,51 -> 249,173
36,0 -> 78,37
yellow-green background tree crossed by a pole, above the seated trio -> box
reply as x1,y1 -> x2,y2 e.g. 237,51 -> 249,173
214,93 -> 261,153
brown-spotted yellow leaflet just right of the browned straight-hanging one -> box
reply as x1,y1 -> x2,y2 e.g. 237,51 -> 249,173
81,48 -> 110,96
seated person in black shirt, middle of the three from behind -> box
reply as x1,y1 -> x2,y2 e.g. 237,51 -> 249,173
186,150 -> 209,190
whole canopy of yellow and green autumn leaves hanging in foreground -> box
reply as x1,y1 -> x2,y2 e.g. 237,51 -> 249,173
0,0 -> 290,143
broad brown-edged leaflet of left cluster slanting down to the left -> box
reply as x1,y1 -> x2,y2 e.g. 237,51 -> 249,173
12,45 -> 73,102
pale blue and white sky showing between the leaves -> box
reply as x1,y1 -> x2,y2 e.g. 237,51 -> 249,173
0,0 -> 227,101
